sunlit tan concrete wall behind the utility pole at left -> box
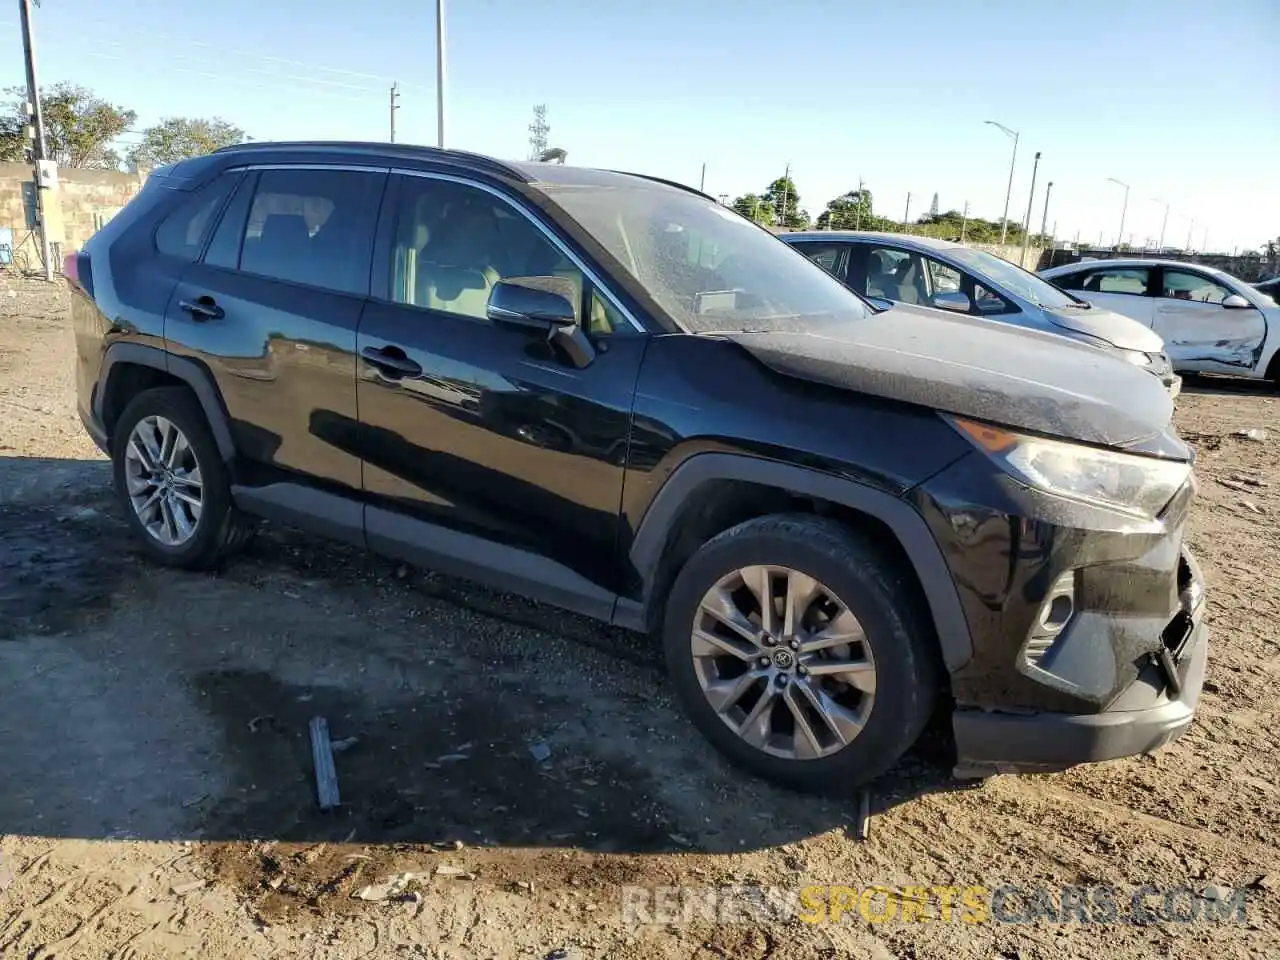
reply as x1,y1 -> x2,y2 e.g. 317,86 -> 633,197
0,164 -> 146,268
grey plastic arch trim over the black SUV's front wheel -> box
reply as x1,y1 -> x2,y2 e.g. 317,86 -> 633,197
624,453 -> 973,672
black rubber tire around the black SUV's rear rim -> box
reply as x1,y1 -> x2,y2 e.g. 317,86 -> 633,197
111,387 -> 255,570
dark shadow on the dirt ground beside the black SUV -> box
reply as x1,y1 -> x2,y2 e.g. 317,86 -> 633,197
0,458 -> 970,854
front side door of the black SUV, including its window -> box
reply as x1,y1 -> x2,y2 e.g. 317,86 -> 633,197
357,174 -> 646,614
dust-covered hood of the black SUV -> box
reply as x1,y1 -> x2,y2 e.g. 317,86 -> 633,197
714,303 -> 1174,447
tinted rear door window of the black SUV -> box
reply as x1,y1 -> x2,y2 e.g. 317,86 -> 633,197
239,169 -> 385,293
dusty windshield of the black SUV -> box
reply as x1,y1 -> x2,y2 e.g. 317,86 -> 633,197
543,184 -> 874,333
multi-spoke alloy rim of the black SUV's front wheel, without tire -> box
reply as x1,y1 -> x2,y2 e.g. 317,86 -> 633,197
691,566 -> 876,760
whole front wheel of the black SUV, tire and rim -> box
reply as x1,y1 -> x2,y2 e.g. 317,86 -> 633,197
663,516 -> 938,792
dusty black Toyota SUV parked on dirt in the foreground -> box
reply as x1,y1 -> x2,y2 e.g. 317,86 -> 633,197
68,143 -> 1207,788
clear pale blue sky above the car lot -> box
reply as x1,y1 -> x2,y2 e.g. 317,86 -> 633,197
0,0 -> 1280,251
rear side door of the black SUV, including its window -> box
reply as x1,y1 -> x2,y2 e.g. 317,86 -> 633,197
165,166 -> 387,504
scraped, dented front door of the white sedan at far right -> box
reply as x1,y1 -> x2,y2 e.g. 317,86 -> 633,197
1155,266 -> 1267,374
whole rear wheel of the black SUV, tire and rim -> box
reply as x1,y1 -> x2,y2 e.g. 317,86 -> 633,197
111,387 -> 252,570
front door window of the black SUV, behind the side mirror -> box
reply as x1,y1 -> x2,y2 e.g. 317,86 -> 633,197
392,177 -> 627,334
